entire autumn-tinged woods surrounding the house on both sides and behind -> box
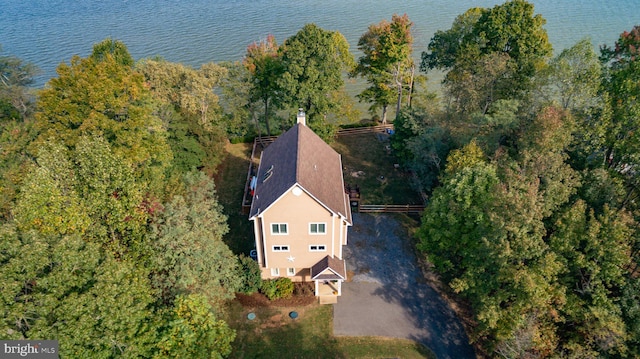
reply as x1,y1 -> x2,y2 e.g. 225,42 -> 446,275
0,0 -> 640,358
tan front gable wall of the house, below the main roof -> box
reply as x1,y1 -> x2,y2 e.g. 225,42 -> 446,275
256,190 -> 344,280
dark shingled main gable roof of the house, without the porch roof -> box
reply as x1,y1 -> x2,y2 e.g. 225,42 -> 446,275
249,124 -> 351,223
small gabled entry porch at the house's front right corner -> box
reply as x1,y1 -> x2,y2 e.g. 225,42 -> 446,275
311,256 -> 347,304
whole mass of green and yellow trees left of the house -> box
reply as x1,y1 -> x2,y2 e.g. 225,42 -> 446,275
0,39 -> 250,358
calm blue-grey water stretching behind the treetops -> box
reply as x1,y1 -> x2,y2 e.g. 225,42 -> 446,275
0,0 -> 640,85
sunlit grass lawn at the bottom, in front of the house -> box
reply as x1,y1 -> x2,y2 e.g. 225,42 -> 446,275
222,302 -> 434,358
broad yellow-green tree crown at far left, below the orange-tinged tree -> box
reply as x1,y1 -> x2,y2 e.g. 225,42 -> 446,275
14,137 -> 148,256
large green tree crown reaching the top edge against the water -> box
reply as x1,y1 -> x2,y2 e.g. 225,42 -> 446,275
420,0 -> 552,113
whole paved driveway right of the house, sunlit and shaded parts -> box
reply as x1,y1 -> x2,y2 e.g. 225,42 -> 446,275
333,213 -> 475,358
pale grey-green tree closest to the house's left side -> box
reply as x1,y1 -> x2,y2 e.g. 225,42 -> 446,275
152,173 -> 241,309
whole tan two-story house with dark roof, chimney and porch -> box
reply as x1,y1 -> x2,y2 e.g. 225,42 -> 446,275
249,111 -> 352,302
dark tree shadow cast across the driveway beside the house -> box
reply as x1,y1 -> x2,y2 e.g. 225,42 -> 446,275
345,213 -> 475,358
